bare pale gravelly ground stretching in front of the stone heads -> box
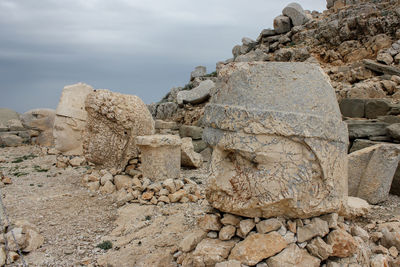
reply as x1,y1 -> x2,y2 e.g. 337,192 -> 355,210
0,146 -> 400,266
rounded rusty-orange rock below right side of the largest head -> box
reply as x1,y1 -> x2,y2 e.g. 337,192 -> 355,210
326,229 -> 358,258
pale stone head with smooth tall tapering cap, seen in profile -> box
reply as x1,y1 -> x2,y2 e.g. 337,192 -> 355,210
53,83 -> 93,155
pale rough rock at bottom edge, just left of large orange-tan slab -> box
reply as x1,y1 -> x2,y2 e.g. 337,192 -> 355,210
193,238 -> 235,266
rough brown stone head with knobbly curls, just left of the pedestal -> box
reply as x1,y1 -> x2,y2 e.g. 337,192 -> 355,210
83,90 -> 154,171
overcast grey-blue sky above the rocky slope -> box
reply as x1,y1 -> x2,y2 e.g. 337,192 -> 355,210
0,0 -> 326,112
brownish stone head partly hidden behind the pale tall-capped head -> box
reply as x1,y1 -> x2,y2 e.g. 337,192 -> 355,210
21,108 -> 56,146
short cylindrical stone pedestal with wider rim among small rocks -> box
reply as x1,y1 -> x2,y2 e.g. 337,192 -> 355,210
136,135 -> 182,181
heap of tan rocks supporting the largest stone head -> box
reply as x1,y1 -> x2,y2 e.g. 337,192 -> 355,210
174,209 -> 400,267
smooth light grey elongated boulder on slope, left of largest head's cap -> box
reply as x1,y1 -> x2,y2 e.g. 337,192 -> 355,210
177,80 -> 215,105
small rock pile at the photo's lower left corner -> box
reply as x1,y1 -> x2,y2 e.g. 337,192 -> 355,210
0,220 -> 44,266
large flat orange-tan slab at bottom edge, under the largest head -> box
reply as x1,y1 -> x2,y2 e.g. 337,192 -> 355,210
229,232 -> 287,265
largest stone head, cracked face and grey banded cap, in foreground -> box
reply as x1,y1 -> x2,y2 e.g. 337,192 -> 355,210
203,62 -> 348,218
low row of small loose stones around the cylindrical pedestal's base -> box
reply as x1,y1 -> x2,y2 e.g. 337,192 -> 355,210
82,170 -> 204,206
